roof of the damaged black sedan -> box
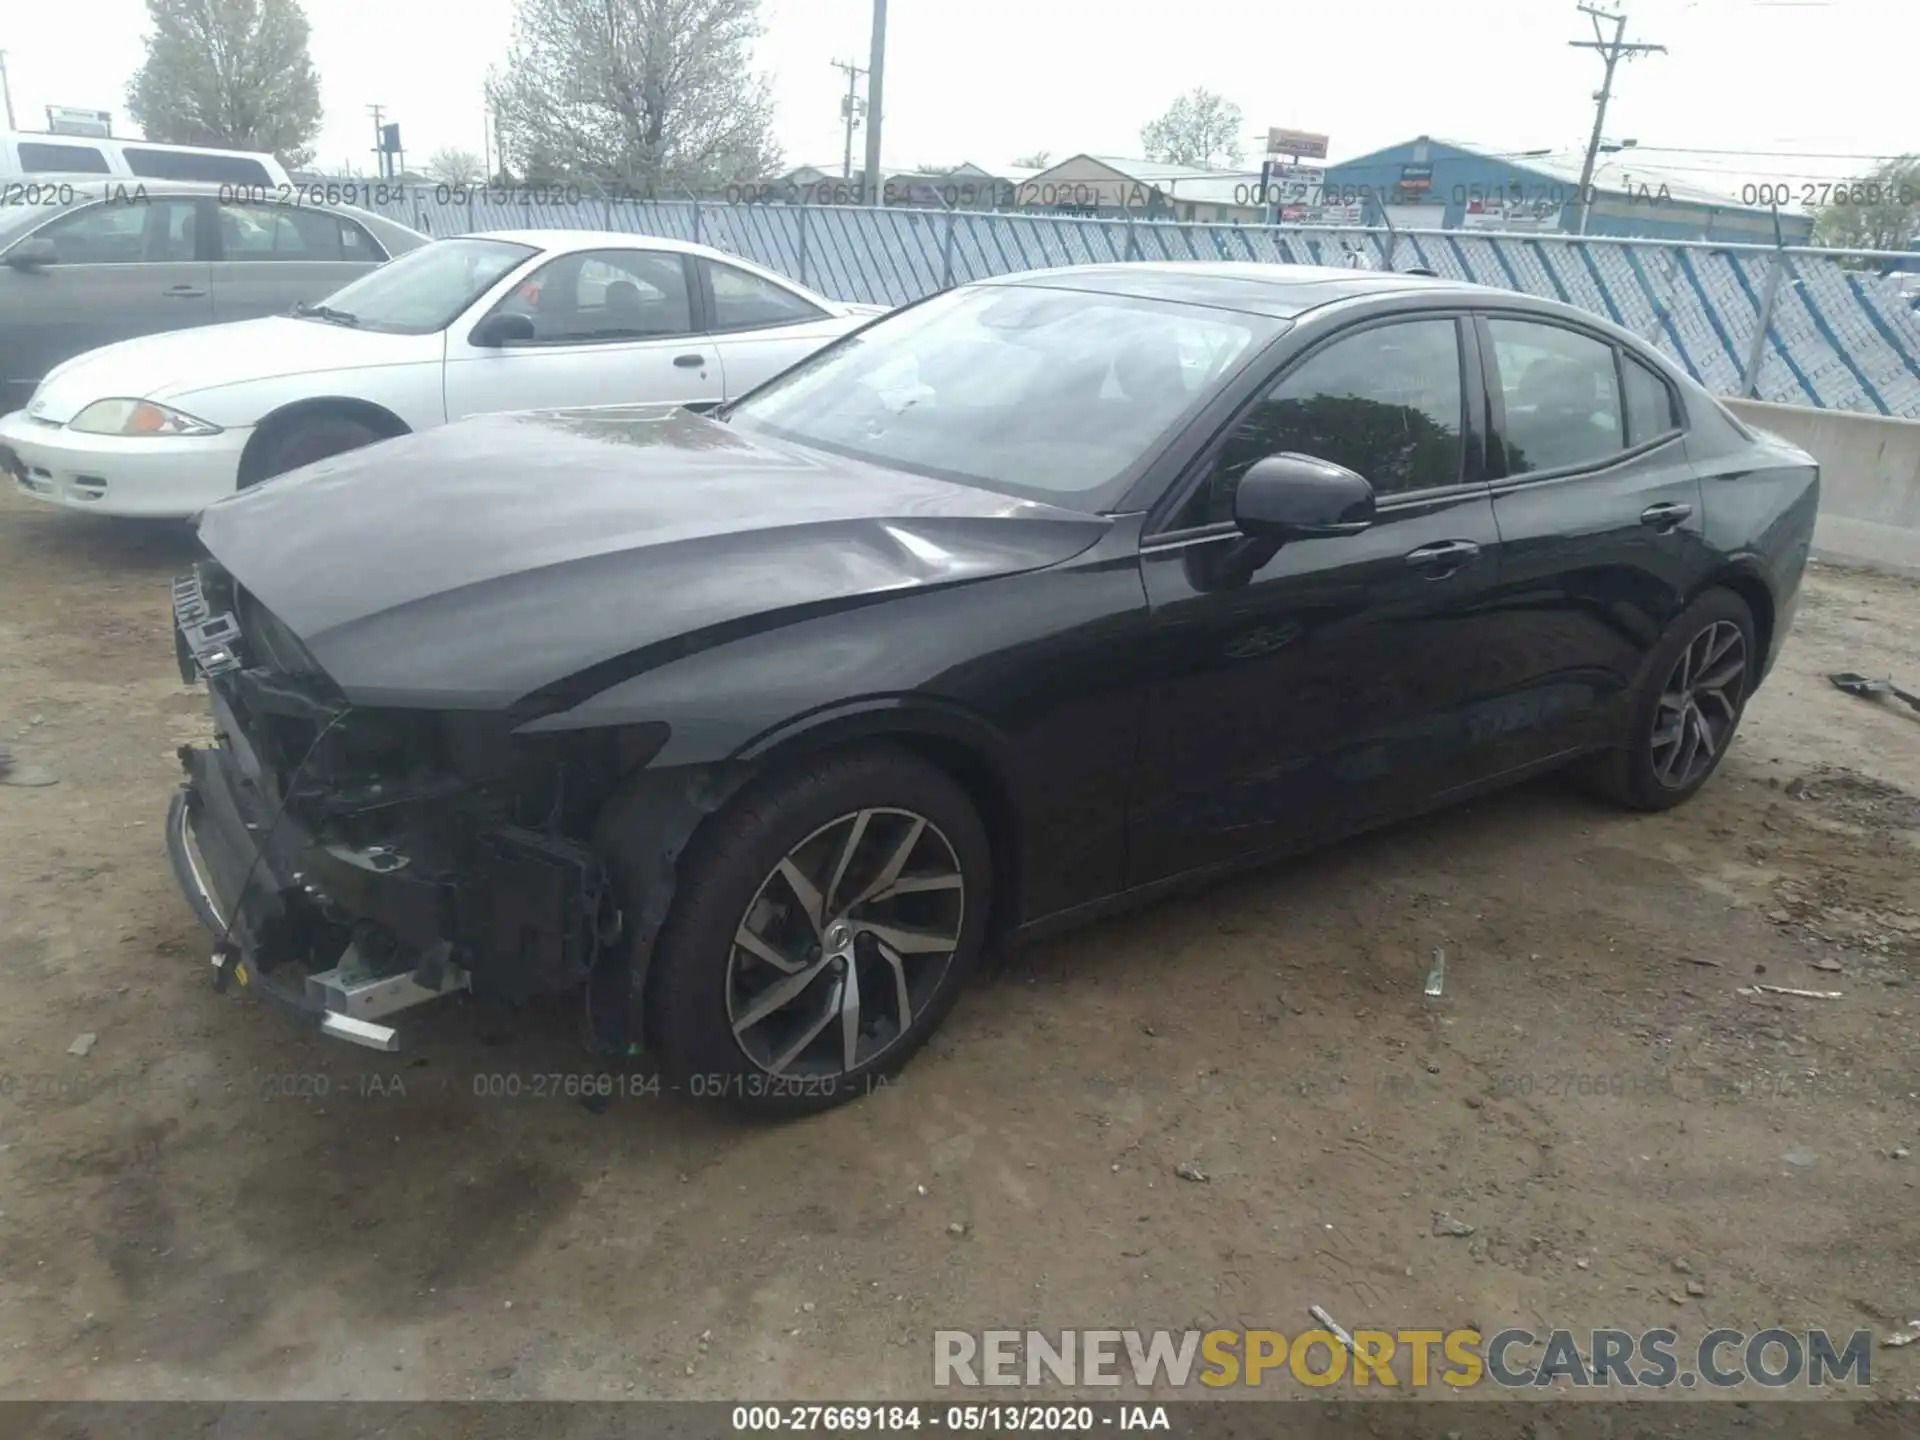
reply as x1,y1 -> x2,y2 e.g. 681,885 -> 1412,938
979,259 -> 1513,321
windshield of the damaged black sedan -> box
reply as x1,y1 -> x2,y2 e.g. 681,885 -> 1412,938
726,284 -> 1284,511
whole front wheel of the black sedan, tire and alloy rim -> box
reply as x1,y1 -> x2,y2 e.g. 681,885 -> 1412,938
647,747 -> 993,1116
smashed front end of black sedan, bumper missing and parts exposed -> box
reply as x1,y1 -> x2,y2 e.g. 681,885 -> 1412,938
167,561 -> 691,1050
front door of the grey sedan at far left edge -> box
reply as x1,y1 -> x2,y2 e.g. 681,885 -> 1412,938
0,188 -> 213,413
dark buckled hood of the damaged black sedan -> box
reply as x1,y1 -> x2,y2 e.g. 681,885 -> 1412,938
200,407 -> 1110,708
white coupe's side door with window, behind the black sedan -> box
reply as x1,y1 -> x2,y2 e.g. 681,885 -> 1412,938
447,248 -> 724,420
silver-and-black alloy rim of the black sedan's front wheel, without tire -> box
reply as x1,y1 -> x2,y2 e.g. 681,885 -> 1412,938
726,808 -> 966,1075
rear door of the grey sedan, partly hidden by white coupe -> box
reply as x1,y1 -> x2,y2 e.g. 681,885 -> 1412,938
213,200 -> 386,321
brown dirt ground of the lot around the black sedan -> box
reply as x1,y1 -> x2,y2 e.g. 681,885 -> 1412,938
0,493 -> 1920,1400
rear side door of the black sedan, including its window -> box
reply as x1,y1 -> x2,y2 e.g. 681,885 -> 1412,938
1478,311 -> 1707,766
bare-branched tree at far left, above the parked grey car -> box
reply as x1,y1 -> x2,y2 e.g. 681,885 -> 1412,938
127,0 -> 321,169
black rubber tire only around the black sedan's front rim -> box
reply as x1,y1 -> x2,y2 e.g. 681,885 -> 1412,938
645,747 -> 993,1116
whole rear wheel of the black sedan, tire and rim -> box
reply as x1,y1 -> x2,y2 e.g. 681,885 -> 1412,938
1574,589 -> 1759,810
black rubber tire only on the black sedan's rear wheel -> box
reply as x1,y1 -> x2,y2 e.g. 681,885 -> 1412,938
1569,589 -> 1761,810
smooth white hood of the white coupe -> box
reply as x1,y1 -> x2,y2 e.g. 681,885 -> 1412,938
27,315 -> 420,424
